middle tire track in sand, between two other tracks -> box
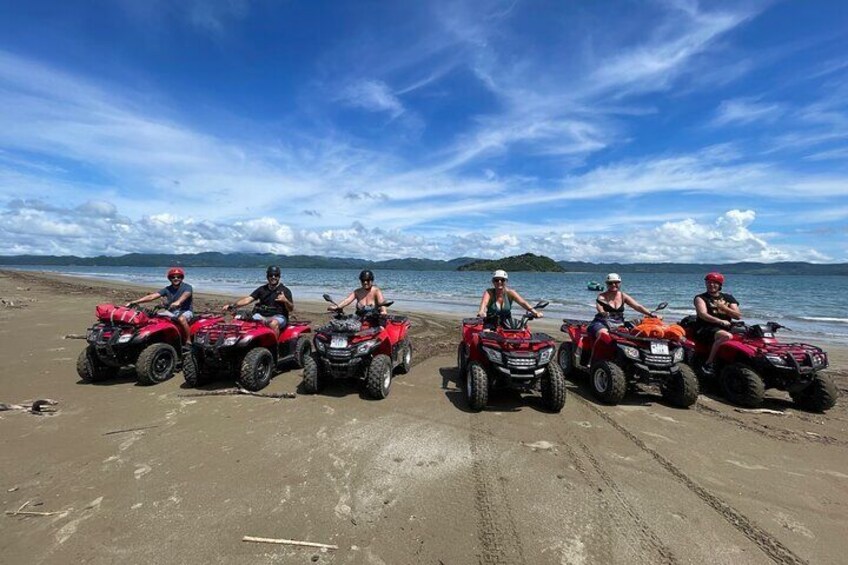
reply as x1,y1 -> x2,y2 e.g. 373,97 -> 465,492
557,433 -> 678,565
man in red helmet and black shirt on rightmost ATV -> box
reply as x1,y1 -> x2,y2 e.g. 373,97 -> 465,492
695,273 -> 742,373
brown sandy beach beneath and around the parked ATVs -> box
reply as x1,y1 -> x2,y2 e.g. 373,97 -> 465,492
0,271 -> 848,564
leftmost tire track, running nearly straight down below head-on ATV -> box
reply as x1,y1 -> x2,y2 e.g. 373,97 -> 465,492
470,414 -> 526,565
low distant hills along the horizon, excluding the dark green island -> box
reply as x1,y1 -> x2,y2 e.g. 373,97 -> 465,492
0,252 -> 848,276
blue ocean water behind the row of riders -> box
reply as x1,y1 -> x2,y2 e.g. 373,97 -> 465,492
4,266 -> 848,343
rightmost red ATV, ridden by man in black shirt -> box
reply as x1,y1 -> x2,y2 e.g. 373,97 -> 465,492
680,316 -> 839,412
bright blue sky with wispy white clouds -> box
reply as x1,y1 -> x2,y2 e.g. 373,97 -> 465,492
0,0 -> 848,262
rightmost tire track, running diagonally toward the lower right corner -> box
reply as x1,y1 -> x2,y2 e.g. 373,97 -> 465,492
573,395 -> 809,565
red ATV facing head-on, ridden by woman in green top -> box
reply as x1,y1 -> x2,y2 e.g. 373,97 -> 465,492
456,302 -> 565,412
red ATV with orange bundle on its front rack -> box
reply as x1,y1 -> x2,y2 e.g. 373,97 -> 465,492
557,302 -> 698,408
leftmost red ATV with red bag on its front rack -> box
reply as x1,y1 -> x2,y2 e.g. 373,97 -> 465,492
77,304 -> 221,384
